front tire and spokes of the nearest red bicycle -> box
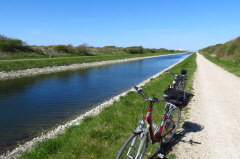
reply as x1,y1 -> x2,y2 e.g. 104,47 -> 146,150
116,132 -> 148,159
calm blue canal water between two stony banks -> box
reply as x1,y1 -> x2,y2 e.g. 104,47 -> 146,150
0,53 -> 189,153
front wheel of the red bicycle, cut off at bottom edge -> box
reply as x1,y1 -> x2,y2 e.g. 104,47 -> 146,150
116,132 -> 148,159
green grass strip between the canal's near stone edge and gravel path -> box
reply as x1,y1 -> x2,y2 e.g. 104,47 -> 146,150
20,54 -> 196,159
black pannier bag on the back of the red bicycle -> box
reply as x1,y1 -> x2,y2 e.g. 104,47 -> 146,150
164,88 -> 194,108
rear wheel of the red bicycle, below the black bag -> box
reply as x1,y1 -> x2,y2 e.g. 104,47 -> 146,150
161,107 -> 181,144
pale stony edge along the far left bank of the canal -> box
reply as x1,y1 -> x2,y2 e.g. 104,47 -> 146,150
0,53 -> 185,81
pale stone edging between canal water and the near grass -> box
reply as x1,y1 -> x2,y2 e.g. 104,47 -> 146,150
0,54 -> 191,159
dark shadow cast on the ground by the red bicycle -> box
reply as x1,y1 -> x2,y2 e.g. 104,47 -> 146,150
149,121 -> 204,159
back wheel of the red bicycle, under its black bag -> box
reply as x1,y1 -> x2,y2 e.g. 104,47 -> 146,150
161,105 -> 181,144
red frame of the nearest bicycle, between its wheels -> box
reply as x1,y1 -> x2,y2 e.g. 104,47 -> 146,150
134,102 -> 176,143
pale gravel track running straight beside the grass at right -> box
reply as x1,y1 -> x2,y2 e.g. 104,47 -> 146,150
175,54 -> 240,159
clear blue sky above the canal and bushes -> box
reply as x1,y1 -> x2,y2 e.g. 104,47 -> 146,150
0,0 -> 240,50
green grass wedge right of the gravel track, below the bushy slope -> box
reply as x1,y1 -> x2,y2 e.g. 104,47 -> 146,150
202,53 -> 240,77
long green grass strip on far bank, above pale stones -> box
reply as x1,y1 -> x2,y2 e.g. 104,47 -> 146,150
0,52 -> 180,71
